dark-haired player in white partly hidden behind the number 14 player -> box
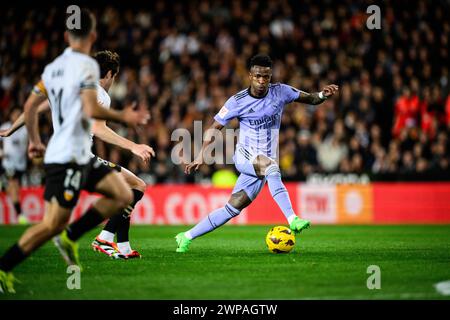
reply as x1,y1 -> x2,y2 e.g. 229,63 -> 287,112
0,50 -> 155,259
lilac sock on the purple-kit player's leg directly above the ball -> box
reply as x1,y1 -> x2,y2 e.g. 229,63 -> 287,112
265,164 -> 295,221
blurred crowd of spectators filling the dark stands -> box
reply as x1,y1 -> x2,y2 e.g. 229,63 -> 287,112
0,0 -> 450,183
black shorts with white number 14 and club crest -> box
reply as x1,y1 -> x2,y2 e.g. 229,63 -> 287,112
44,158 -> 112,209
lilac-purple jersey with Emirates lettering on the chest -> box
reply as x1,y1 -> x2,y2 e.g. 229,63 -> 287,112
214,83 -> 300,159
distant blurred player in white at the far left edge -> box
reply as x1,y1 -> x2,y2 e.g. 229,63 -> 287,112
0,108 -> 28,224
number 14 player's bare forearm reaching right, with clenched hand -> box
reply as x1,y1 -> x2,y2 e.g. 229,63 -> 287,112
81,89 -> 150,127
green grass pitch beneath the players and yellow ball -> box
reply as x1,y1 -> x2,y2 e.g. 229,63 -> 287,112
0,225 -> 450,300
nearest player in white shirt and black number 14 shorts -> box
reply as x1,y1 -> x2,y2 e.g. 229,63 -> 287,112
0,10 -> 149,293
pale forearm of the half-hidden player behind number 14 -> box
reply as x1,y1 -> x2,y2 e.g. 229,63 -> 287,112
92,120 -> 155,162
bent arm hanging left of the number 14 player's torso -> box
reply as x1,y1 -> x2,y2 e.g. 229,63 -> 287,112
24,92 -> 47,158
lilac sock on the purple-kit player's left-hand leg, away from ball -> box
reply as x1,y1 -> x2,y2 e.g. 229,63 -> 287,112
185,203 -> 241,239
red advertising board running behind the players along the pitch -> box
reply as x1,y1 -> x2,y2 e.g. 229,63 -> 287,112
0,183 -> 450,225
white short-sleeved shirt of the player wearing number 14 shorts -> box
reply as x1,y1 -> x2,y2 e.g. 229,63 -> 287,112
35,48 -> 100,165
